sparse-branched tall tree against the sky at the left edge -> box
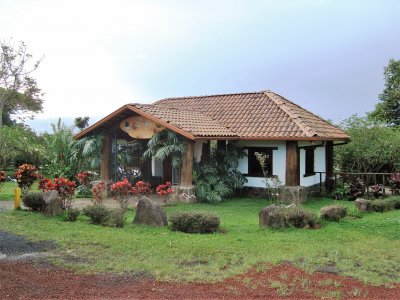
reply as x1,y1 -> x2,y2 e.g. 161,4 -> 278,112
0,41 -> 43,128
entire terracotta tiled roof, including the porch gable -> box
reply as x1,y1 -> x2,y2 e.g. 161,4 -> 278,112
75,91 -> 349,140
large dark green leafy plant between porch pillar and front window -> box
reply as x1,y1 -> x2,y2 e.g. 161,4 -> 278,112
193,143 -> 247,203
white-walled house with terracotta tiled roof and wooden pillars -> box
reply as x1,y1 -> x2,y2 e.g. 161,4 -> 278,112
76,90 -> 349,199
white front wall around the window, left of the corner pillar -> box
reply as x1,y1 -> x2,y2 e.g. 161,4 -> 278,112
238,141 -> 286,188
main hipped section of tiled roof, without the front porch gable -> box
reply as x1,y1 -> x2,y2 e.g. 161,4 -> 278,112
154,91 -> 349,140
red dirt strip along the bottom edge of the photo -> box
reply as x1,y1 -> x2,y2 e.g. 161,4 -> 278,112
0,261 -> 400,299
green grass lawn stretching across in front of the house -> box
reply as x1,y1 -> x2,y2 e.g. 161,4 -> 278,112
0,198 -> 400,284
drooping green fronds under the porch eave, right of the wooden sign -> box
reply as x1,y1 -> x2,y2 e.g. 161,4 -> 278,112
143,129 -> 185,168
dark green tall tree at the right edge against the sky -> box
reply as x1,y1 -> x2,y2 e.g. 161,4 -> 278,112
369,59 -> 400,126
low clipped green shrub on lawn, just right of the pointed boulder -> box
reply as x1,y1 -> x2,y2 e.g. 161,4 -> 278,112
171,212 -> 220,233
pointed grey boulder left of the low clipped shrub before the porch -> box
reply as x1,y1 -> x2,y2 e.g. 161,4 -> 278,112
133,197 -> 168,227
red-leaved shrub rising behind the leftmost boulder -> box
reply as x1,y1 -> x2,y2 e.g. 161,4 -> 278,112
39,177 -> 76,210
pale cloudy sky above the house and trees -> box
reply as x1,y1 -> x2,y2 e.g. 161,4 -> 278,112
0,0 -> 400,129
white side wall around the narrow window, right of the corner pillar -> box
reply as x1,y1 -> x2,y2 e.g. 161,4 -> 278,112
299,142 -> 326,186
